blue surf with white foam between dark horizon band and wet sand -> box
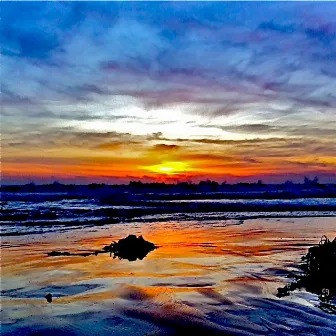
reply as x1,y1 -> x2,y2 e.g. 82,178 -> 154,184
0,192 -> 336,236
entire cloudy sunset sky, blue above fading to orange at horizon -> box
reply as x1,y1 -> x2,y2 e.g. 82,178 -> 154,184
0,1 -> 336,184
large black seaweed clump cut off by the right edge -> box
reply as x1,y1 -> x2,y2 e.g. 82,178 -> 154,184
277,236 -> 336,313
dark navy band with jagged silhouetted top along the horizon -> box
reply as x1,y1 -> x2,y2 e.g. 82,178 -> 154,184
0,178 -> 336,203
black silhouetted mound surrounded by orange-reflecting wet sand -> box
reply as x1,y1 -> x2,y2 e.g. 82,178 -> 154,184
103,235 -> 156,261
